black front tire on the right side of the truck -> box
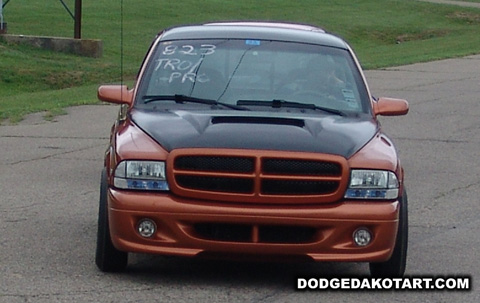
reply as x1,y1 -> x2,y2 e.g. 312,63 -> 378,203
370,190 -> 408,278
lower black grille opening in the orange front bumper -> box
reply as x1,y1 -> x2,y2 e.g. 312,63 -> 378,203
193,223 -> 316,244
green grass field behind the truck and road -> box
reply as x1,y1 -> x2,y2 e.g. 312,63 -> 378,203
0,0 -> 480,122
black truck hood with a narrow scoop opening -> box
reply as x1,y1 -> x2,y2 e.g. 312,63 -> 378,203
130,109 -> 378,158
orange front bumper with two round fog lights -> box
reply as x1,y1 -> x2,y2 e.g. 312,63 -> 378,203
108,189 -> 399,262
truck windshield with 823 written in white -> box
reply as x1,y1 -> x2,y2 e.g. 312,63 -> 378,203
136,39 -> 368,113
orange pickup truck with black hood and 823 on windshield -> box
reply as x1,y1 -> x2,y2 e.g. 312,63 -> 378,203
96,22 -> 408,277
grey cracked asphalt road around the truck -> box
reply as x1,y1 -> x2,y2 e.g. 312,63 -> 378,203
0,56 -> 480,303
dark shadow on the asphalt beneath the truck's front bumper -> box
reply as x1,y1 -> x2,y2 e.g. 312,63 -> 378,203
120,255 -> 369,290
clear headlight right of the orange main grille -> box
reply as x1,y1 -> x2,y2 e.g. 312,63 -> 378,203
345,169 -> 399,200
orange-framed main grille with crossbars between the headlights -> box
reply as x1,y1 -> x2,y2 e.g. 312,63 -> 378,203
167,149 -> 349,204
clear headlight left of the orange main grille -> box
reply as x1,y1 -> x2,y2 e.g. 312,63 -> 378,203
113,160 -> 169,191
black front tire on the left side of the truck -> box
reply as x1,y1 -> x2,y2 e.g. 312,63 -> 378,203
95,169 -> 128,272
